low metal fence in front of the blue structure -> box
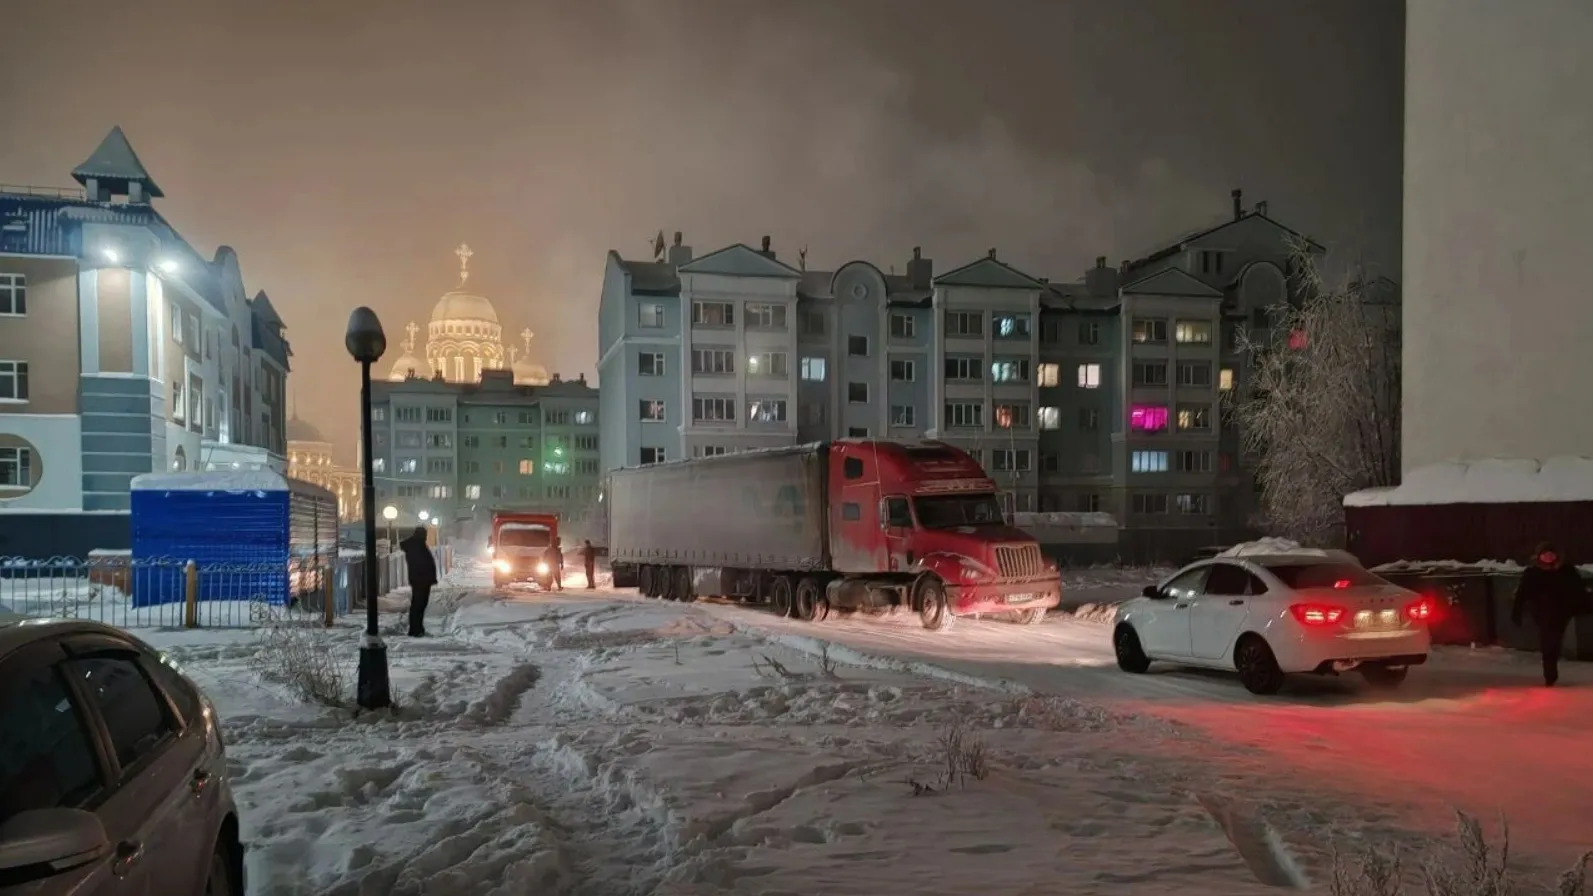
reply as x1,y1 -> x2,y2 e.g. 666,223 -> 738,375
0,548 -> 452,628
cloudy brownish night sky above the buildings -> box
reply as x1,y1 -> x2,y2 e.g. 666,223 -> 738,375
0,0 -> 1403,456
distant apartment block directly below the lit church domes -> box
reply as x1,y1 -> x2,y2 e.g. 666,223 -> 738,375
371,368 -> 599,540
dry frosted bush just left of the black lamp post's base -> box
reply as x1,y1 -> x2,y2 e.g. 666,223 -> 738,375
250,601 -> 352,708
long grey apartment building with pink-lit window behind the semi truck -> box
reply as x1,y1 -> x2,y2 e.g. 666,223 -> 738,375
597,191 -> 1321,556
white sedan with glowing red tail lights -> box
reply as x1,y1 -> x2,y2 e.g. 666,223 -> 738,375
1112,550 -> 1437,694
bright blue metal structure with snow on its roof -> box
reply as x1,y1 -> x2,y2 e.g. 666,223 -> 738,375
132,470 -> 338,606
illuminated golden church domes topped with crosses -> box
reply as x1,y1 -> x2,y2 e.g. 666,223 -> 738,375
387,246 -> 551,386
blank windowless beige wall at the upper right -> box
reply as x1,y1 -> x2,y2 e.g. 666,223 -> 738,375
1402,0 -> 1593,470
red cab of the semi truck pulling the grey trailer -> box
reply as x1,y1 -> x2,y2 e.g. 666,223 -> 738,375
828,440 -> 1063,627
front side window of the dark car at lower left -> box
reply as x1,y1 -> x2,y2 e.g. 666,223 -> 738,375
0,660 -> 100,813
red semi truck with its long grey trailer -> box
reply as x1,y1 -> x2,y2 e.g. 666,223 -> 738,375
605,438 -> 1063,630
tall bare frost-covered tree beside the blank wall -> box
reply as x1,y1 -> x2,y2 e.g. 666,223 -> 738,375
1233,239 -> 1400,545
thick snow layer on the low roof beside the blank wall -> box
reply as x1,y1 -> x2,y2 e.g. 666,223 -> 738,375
1344,456 -> 1593,507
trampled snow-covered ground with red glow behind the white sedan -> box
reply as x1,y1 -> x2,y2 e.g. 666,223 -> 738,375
127,568 -> 1593,896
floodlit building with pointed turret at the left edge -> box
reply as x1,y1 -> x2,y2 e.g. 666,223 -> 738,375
0,128 -> 292,553
